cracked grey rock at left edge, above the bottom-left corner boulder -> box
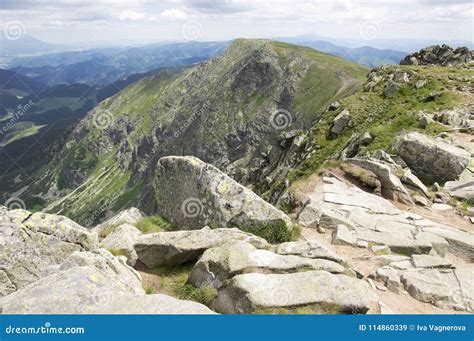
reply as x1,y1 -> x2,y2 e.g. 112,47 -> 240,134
0,210 -> 98,296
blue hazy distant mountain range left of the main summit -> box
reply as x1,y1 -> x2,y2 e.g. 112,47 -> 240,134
8,42 -> 229,85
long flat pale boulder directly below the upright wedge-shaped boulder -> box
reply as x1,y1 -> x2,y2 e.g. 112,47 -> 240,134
135,227 -> 269,268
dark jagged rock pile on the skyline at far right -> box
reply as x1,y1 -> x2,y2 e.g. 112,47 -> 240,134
400,44 -> 474,66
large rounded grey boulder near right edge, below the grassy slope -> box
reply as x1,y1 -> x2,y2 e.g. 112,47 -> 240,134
395,132 -> 471,182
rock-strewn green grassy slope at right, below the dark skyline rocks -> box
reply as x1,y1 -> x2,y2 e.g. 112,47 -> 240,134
290,66 -> 474,186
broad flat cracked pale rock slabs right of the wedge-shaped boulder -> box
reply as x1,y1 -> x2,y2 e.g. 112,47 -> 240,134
310,177 -> 474,261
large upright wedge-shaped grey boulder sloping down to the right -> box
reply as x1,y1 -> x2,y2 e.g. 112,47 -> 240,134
154,156 -> 292,235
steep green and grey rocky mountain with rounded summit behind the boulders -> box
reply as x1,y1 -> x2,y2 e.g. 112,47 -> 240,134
19,40 -> 367,223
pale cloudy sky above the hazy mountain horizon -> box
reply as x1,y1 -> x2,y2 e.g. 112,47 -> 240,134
0,0 -> 474,44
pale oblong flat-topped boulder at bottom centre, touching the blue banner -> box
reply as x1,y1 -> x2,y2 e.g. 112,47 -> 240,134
216,270 -> 377,314
